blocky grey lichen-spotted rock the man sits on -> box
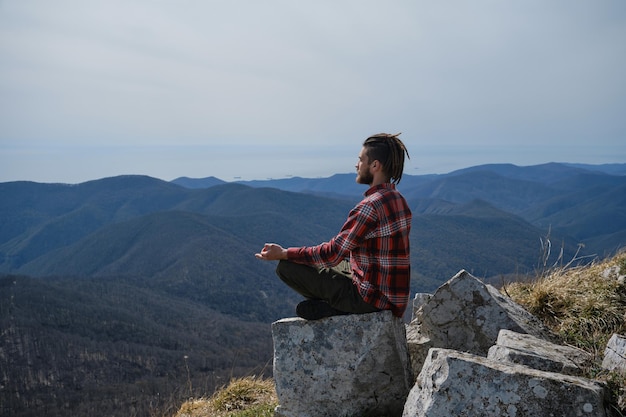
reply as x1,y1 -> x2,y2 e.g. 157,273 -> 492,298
272,311 -> 413,417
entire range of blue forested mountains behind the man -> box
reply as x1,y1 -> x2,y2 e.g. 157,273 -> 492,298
0,163 -> 626,416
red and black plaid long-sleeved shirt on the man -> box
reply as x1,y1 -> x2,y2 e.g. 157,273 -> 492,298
287,183 -> 411,317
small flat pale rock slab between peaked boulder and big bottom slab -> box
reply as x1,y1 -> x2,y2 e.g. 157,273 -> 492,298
487,330 -> 593,376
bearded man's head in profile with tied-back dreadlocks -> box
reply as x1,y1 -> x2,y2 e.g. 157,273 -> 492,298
357,133 -> 409,185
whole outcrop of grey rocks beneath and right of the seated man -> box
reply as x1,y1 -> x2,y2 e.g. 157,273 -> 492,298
272,271 -> 626,417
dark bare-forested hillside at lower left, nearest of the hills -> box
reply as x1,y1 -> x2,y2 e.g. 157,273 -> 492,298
0,275 -> 272,417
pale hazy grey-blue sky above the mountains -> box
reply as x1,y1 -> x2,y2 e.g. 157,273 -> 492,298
0,0 -> 626,183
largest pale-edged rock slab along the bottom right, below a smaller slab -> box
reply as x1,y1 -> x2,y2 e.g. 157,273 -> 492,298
403,349 -> 606,417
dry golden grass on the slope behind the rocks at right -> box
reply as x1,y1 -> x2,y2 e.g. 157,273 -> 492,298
503,252 -> 626,356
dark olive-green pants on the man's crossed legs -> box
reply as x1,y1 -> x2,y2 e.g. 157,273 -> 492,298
276,261 -> 380,314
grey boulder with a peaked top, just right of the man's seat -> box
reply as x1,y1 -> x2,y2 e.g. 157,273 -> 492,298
409,270 -> 556,356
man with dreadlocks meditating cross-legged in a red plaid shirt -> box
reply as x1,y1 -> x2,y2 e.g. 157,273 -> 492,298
255,133 -> 411,320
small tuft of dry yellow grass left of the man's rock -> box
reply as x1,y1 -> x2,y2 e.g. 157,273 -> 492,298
174,377 -> 278,417
